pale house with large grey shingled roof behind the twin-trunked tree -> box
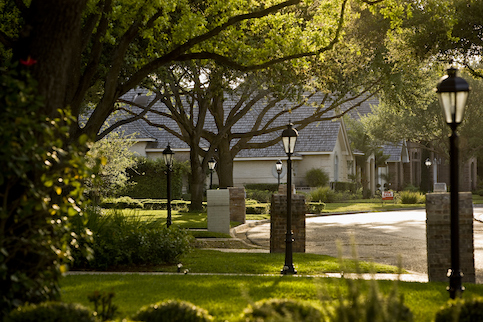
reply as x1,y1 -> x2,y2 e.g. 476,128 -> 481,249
115,93 -> 377,191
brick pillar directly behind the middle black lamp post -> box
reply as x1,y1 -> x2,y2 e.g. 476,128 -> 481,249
270,194 -> 306,253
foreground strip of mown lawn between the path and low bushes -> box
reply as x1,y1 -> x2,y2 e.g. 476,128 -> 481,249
61,274 -> 483,321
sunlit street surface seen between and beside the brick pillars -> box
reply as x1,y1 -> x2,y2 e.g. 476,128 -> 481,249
246,207 -> 483,283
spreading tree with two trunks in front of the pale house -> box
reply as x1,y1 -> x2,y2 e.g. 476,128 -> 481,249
114,0 -> 414,207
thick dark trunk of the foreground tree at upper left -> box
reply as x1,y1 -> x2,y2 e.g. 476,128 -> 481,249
13,0 -> 87,117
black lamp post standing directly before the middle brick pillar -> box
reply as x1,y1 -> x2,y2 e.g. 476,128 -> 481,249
281,123 -> 299,275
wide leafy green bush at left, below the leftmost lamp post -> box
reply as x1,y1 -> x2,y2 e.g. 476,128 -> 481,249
74,209 -> 192,269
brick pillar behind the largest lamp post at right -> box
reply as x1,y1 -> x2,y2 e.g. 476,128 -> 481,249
426,192 -> 475,283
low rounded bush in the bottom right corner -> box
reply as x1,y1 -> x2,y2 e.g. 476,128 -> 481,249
434,298 -> 483,322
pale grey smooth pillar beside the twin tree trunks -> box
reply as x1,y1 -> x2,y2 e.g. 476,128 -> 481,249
206,189 -> 230,234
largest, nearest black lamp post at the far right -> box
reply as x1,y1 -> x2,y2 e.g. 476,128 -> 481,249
436,67 -> 470,299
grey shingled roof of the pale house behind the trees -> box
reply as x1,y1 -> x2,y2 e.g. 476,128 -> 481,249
111,89 -> 377,158
